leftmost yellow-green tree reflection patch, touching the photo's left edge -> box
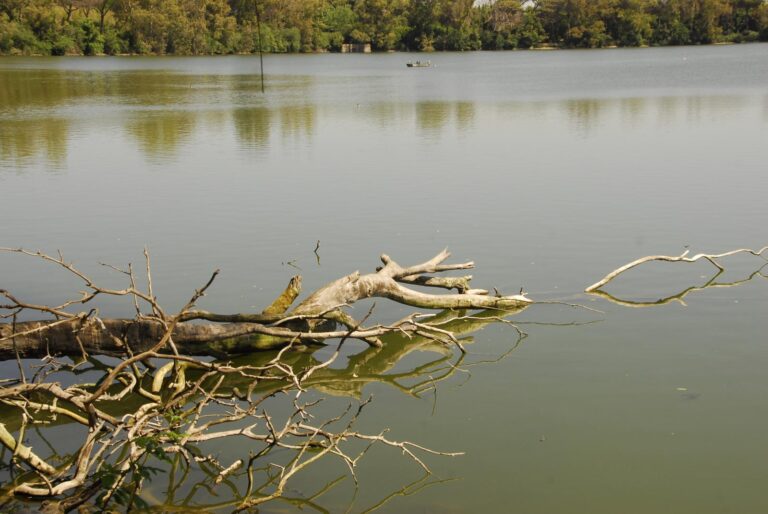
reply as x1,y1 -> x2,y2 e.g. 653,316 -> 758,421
0,118 -> 69,168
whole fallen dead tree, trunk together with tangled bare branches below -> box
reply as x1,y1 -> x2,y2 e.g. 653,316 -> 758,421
0,249 -> 532,512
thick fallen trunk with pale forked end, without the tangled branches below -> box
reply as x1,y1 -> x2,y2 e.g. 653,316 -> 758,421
0,248 -> 531,359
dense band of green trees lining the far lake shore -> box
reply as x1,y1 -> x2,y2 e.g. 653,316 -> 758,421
0,0 -> 768,55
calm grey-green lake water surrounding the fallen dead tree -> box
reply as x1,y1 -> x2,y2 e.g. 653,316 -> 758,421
0,44 -> 768,514
